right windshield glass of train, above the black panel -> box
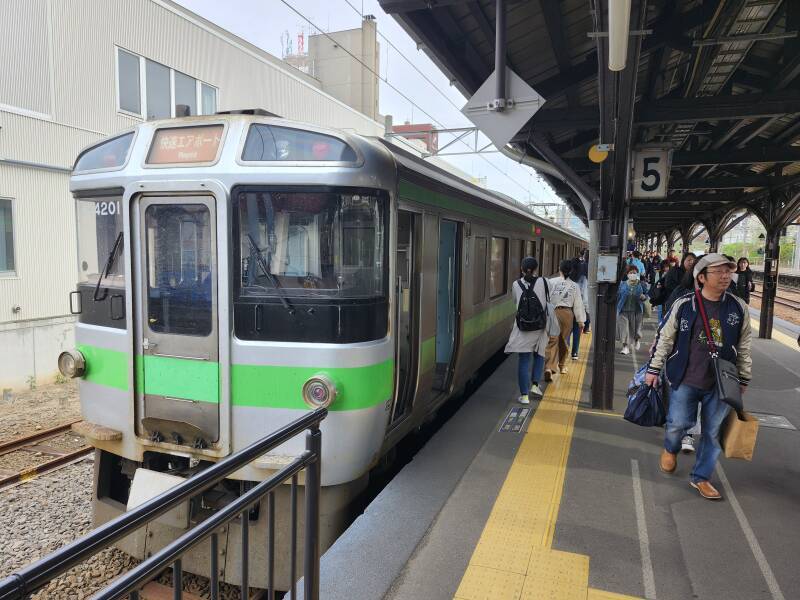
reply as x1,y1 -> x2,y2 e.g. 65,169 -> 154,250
237,191 -> 386,298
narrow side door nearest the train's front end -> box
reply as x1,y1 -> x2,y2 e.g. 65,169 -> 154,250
391,210 -> 420,423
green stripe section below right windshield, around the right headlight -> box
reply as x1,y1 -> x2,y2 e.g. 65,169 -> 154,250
231,359 -> 394,410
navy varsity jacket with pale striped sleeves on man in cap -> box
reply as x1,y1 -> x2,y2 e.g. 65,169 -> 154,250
647,291 -> 753,389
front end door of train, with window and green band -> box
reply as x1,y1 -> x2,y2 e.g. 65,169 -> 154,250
135,196 -> 219,447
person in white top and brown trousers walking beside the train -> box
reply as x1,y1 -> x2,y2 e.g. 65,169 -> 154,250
544,260 -> 586,381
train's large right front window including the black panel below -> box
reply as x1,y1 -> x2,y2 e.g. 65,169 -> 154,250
234,191 -> 388,343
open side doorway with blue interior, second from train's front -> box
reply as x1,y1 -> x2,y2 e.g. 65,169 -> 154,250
433,219 -> 461,391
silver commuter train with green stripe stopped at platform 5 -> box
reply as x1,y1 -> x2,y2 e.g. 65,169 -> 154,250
59,110 -> 587,589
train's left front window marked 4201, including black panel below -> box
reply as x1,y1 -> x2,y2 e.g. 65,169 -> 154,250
75,197 -> 125,329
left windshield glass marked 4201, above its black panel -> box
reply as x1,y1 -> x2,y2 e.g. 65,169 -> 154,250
76,198 -> 125,288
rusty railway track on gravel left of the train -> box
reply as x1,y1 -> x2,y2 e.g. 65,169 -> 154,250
0,420 -> 93,489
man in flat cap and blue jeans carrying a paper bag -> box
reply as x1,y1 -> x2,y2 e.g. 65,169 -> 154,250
645,254 -> 753,500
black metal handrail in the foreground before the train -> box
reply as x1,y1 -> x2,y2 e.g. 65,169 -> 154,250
0,408 -> 328,600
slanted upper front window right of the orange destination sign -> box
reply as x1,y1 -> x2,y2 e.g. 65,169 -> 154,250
242,123 -> 356,162
